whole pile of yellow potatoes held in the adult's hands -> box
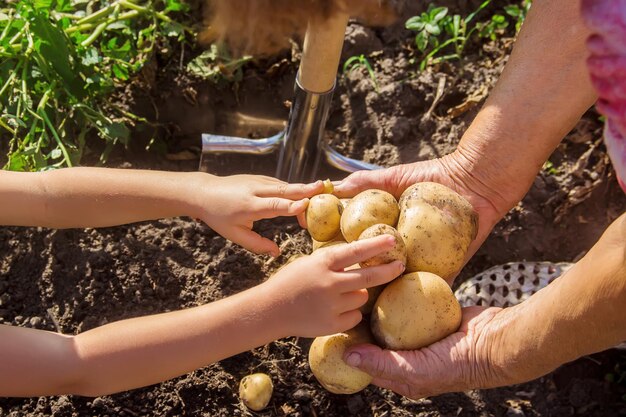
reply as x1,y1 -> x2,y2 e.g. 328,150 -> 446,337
306,182 -> 478,394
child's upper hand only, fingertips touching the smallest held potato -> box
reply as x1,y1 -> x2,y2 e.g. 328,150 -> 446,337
195,174 -> 324,256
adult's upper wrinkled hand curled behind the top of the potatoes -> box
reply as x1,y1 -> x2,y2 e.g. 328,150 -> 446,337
326,155 -> 509,274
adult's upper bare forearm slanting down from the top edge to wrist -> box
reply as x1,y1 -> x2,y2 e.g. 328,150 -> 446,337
442,0 -> 595,214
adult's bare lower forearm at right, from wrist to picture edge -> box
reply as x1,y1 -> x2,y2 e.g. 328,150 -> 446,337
494,215 -> 626,382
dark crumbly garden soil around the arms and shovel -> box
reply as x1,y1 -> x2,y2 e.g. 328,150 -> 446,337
0,1 -> 626,417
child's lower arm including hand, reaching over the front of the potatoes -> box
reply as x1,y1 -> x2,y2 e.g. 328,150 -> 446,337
0,236 -> 403,396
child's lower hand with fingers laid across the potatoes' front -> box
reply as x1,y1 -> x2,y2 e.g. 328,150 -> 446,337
263,235 -> 404,337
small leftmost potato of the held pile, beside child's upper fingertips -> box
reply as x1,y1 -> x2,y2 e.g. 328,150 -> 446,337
305,194 -> 343,242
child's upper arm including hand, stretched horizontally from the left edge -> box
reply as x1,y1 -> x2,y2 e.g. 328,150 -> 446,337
0,168 -> 323,255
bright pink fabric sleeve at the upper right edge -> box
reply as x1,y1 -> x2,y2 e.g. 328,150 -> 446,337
582,0 -> 626,192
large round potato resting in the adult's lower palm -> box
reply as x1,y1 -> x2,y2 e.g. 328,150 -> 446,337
371,272 -> 461,350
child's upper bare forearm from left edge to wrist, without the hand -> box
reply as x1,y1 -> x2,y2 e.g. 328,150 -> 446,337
0,168 -> 201,228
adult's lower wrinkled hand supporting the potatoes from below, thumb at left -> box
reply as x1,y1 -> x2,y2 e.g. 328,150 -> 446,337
344,307 -> 509,399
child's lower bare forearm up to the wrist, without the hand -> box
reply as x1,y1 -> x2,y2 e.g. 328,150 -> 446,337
0,286 -> 288,396
